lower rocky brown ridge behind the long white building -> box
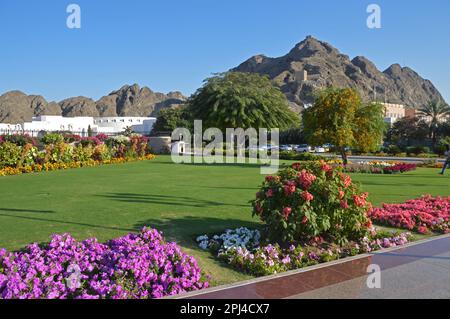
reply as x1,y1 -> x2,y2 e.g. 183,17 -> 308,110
0,84 -> 186,124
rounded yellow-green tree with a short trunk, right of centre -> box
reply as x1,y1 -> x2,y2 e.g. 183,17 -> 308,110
303,88 -> 385,165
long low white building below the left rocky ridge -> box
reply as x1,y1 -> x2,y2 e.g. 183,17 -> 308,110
0,115 -> 156,136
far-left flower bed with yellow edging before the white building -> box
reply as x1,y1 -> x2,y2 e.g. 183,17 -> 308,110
0,133 -> 154,176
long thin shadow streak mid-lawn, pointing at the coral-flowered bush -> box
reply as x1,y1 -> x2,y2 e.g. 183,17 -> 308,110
95,193 -> 249,208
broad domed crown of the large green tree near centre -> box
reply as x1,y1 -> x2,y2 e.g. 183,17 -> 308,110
188,72 -> 300,131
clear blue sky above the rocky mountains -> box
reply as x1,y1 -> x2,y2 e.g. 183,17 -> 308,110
0,0 -> 450,101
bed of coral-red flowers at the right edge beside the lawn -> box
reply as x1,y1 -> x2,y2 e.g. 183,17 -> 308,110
369,195 -> 450,234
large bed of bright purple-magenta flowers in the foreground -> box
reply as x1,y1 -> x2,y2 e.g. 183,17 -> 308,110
0,228 -> 208,299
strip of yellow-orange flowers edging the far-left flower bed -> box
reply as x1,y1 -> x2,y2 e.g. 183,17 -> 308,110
0,154 -> 156,176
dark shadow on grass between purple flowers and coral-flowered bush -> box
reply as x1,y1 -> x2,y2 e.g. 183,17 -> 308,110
134,216 -> 261,250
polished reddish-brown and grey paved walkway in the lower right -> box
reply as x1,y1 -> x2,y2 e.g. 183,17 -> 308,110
180,235 -> 450,299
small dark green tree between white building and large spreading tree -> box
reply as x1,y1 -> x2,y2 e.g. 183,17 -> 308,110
152,107 -> 192,134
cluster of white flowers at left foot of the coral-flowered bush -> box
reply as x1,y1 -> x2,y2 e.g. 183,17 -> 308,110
197,227 -> 261,252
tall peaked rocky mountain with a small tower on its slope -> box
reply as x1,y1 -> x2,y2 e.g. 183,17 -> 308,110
233,36 -> 443,110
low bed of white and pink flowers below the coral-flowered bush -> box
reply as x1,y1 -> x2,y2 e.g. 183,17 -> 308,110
197,228 -> 412,276
